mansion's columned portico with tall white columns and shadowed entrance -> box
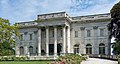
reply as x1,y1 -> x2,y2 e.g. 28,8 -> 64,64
38,24 -> 69,56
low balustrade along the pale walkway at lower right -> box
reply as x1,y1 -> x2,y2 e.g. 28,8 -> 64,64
88,54 -> 120,60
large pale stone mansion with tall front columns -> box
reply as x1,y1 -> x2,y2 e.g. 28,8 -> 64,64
15,12 -> 111,56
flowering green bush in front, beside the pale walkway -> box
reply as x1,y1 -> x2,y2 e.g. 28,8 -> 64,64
57,54 -> 86,64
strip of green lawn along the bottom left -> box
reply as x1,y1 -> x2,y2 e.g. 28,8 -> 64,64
0,61 -> 51,64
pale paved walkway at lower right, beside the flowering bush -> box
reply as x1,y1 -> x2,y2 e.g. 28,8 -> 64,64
81,58 -> 118,64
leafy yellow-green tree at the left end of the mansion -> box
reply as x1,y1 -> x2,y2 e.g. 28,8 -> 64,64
0,18 -> 19,55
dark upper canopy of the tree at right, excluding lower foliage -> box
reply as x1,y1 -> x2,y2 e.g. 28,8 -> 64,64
108,2 -> 120,40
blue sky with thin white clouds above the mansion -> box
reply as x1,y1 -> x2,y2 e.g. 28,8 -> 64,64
0,0 -> 119,24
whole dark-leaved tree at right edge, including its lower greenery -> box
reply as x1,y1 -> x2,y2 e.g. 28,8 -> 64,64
108,2 -> 120,54
